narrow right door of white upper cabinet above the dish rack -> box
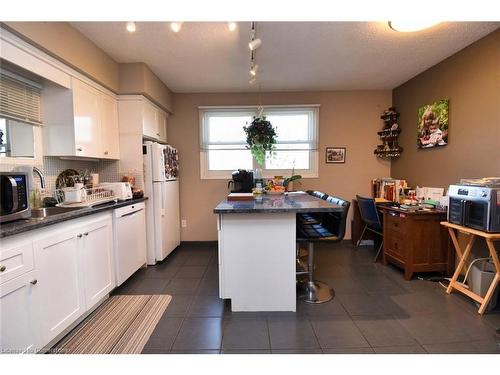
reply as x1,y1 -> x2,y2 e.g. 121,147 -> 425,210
99,94 -> 120,159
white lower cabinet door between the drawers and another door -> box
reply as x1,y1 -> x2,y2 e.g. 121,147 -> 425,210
34,230 -> 86,344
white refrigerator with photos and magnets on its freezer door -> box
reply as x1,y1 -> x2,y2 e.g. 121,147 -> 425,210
142,141 -> 181,265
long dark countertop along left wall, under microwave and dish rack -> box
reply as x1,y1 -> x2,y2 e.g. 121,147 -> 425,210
0,197 -> 148,238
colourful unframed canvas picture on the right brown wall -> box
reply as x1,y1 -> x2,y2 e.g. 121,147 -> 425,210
417,99 -> 448,148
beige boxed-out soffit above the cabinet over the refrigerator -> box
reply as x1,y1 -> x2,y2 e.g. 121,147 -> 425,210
119,63 -> 173,113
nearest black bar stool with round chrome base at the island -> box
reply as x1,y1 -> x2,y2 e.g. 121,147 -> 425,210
297,197 -> 350,303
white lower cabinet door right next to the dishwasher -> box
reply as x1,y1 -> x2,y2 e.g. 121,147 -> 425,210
80,218 -> 115,310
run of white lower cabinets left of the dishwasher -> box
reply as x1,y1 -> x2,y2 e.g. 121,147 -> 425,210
0,213 -> 115,353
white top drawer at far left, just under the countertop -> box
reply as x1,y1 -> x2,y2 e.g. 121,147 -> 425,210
0,242 -> 33,284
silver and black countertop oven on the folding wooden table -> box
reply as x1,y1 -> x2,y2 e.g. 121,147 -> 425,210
448,177 -> 500,233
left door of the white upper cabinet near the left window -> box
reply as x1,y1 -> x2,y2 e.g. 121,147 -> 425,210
72,78 -> 102,158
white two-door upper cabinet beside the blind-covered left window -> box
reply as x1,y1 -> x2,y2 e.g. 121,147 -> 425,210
42,77 -> 120,159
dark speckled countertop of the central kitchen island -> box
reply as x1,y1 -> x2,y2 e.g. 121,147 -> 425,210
214,193 -> 342,214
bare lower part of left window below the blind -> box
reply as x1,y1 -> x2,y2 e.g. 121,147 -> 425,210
0,116 -> 35,158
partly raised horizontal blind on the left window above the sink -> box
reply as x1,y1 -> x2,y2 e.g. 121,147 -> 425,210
0,69 -> 42,125
